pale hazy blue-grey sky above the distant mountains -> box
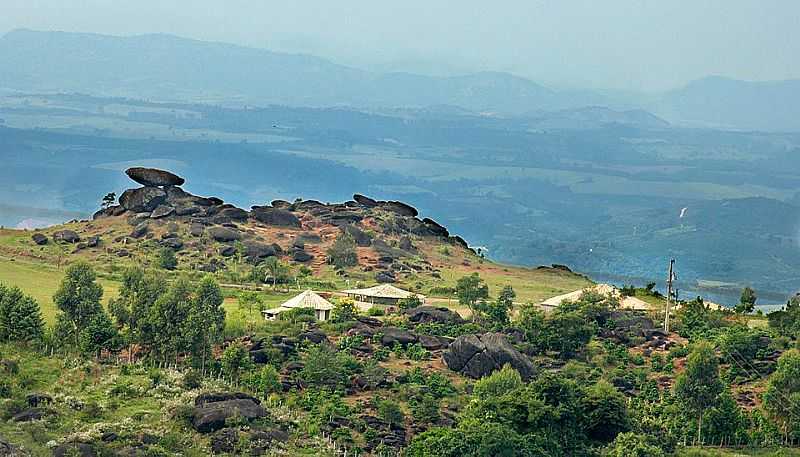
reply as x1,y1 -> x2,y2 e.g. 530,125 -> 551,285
0,0 -> 800,90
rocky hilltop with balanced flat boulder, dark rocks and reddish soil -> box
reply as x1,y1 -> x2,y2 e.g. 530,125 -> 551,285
70,167 -> 474,283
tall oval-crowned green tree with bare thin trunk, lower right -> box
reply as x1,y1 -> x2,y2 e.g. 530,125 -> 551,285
673,341 -> 723,442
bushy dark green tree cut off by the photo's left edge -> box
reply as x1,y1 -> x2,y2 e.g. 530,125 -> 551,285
0,284 -> 44,343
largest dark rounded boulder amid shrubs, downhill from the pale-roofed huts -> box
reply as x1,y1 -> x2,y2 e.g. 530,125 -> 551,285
443,333 -> 536,380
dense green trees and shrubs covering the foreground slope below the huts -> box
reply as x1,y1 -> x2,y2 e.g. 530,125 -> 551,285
0,255 -> 800,457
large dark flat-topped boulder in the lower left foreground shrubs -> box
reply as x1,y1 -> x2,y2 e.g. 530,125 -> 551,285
192,393 -> 267,433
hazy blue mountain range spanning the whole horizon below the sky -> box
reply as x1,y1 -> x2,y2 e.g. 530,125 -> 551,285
0,30 -> 800,131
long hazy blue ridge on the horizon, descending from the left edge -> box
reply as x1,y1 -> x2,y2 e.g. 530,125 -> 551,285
0,30 -> 555,113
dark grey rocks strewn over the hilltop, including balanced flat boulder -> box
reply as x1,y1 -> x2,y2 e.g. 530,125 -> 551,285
84,167 -> 467,274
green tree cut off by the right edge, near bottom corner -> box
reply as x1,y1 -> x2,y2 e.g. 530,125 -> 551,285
763,349 -> 800,438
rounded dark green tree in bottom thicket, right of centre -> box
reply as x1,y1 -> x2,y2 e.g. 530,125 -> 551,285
582,380 -> 630,442
